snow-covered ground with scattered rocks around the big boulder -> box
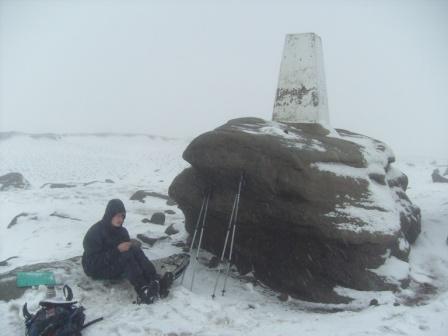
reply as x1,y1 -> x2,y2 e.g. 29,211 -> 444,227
0,135 -> 448,336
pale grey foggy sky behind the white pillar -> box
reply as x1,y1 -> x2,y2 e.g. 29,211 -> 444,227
0,0 -> 448,158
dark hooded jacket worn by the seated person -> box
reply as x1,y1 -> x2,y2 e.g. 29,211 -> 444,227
82,199 -> 130,277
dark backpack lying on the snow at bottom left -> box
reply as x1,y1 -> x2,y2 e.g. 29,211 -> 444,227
22,285 -> 102,336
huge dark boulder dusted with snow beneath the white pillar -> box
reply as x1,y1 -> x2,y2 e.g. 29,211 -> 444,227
169,118 -> 420,302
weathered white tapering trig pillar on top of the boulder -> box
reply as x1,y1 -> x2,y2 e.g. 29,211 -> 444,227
272,33 -> 330,126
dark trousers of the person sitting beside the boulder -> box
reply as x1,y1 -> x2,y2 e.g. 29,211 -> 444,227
86,246 -> 159,291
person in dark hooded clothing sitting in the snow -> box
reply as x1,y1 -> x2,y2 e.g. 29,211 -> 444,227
82,199 -> 173,303
